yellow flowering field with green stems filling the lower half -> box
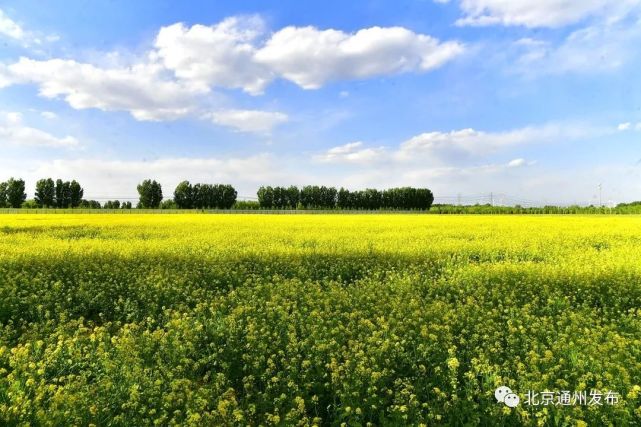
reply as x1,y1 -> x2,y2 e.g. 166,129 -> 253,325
0,213 -> 641,426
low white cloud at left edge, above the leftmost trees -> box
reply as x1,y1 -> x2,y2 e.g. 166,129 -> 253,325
0,112 -> 78,148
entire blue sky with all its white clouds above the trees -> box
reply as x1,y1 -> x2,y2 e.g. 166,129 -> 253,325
0,0 -> 641,203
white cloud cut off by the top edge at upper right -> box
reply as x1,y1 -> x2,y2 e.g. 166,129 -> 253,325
457,0 -> 641,28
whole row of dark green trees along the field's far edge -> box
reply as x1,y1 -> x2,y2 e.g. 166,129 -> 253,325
0,178 -> 434,210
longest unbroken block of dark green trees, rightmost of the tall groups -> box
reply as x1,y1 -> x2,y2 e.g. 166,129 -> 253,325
257,185 -> 434,210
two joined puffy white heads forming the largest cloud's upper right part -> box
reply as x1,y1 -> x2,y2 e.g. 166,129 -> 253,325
151,16 -> 463,95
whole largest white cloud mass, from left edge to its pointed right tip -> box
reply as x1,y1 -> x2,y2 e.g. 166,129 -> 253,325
0,16 -> 463,133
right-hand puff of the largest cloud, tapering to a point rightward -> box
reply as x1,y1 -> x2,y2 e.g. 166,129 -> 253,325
255,27 -> 463,89
